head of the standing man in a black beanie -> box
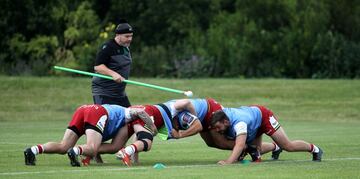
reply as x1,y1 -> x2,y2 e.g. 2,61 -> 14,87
115,20 -> 134,47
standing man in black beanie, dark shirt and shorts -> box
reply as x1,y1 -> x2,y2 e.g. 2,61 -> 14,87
92,21 -> 133,107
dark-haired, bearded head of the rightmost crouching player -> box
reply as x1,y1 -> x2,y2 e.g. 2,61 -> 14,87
210,110 -> 230,134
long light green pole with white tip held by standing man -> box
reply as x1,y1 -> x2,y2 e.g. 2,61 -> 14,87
54,66 -> 193,97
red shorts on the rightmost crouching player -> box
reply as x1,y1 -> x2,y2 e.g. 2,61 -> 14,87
254,105 -> 280,136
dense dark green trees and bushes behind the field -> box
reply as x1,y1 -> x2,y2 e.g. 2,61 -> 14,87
0,0 -> 360,78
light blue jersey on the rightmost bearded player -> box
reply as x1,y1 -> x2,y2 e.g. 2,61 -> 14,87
223,106 -> 262,143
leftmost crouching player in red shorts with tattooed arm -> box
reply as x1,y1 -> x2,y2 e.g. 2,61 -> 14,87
24,104 -> 156,166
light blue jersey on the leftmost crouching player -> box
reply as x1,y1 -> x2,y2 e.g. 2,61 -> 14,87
102,104 -> 126,141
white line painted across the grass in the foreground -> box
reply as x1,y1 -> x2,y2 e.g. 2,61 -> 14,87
0,157 -> 360,176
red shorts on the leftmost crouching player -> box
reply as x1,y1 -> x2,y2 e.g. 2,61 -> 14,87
68,104 -> 108,137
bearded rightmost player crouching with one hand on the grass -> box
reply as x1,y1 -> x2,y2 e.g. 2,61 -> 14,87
211,106 -> 323,165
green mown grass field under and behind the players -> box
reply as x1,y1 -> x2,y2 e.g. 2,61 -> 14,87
0,77 -> 360,179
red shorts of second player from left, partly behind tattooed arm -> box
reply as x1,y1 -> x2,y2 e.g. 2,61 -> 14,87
128,105 -> 164,137
